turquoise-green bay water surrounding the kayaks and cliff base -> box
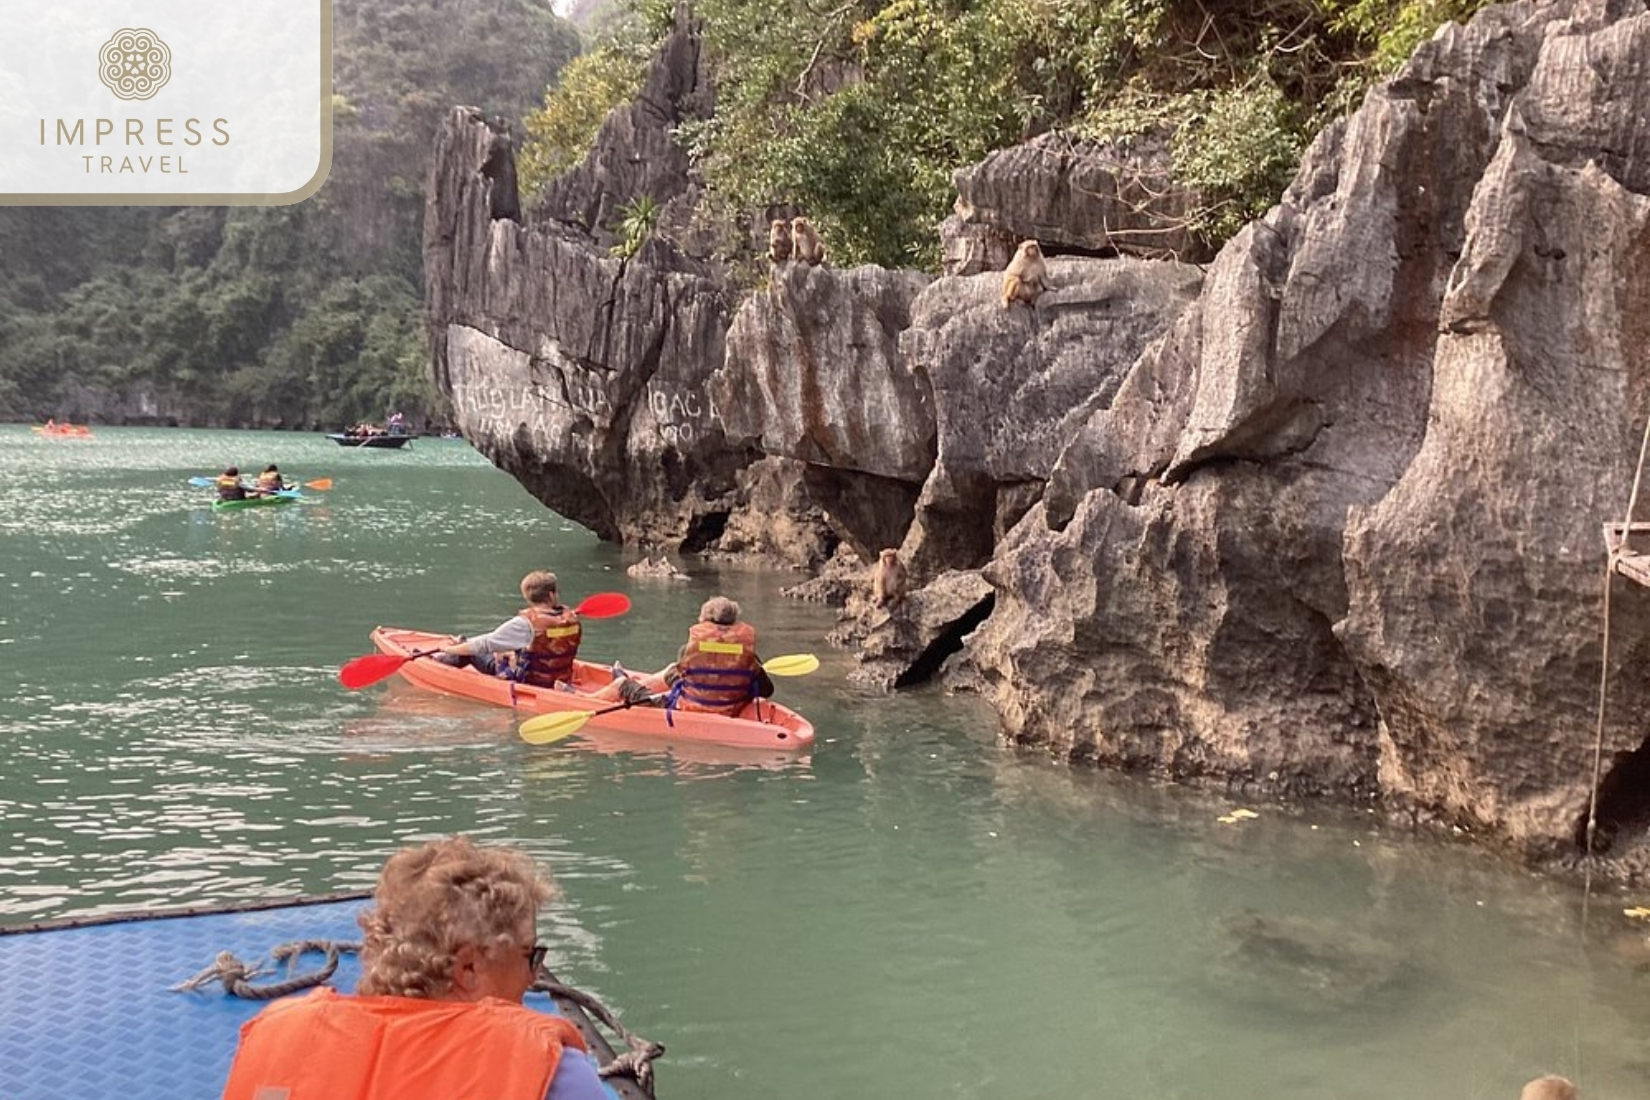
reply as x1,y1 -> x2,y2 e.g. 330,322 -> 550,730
0,425 -> 1650,1100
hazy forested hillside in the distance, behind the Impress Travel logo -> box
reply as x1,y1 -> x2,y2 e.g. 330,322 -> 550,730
0,0 -> 579,427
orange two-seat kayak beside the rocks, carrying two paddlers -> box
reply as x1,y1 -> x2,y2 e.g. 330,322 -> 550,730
373,627 -> 813,750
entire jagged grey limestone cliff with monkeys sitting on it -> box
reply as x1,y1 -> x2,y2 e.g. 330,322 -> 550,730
426,0 -> 1650,874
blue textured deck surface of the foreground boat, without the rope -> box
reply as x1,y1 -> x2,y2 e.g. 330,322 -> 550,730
0,899 -> 619,1100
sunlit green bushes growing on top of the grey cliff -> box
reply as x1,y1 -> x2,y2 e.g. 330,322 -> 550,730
523,0 -> 1485,267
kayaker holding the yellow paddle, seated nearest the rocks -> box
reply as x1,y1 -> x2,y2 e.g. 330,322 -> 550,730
596,595 -> 774,714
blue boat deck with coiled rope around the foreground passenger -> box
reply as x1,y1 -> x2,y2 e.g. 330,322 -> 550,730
0,892 -> 653,1100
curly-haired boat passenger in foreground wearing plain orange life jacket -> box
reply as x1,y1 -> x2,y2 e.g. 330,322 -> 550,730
223,836 -> 607,1100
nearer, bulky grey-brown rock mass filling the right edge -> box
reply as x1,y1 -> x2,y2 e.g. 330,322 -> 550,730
970,3 -> 1650,854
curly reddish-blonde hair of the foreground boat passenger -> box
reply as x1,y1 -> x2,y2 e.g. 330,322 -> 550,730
355,836 -> 554,998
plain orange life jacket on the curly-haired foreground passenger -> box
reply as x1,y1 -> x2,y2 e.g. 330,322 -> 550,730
223,986 -> 584,1100
